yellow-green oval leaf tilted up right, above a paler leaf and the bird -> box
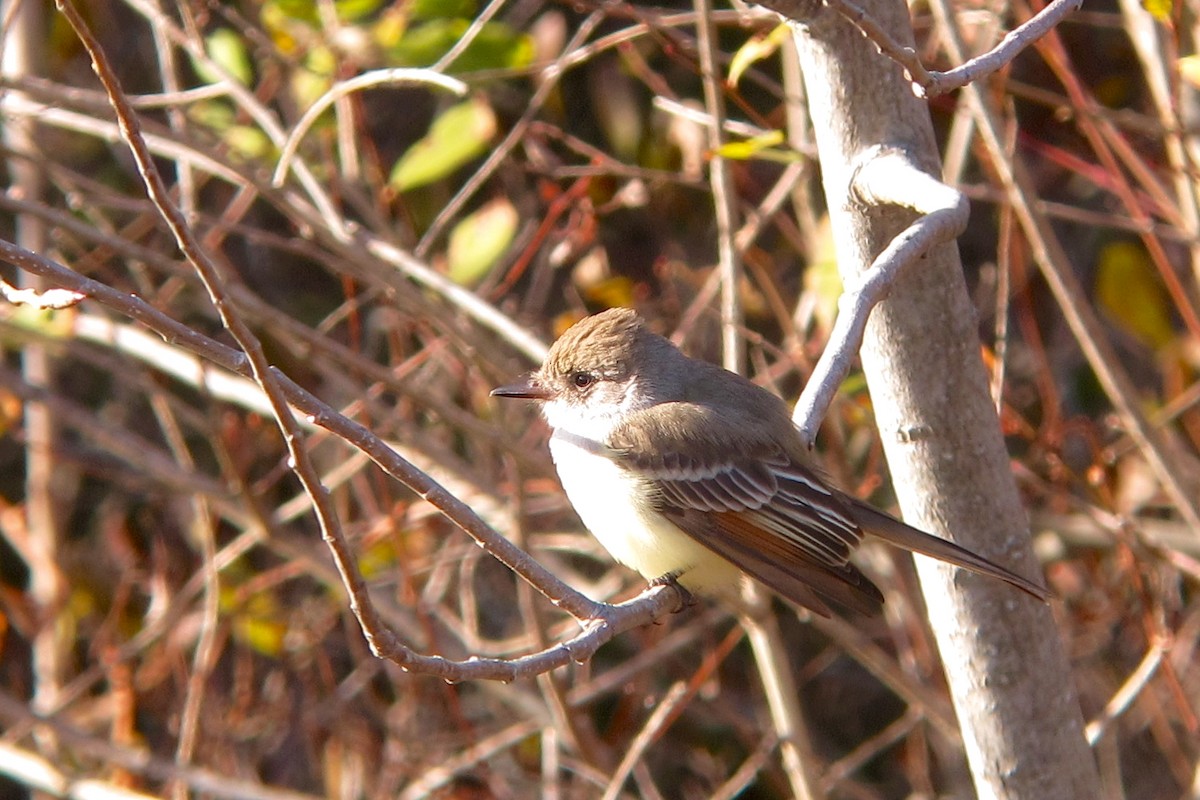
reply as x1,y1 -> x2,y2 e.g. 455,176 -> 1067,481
390,97 -> 496,192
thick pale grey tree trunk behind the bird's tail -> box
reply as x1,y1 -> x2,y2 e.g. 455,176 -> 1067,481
797,0 -> 1099,800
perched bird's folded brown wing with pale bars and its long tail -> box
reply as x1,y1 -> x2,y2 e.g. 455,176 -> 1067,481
612,395 -> 1046,614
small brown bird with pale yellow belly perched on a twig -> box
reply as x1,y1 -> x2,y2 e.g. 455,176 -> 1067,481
492,308 -> 1046,615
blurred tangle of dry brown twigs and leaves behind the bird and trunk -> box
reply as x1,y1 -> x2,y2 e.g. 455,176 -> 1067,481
0,0 -> 1200,800
